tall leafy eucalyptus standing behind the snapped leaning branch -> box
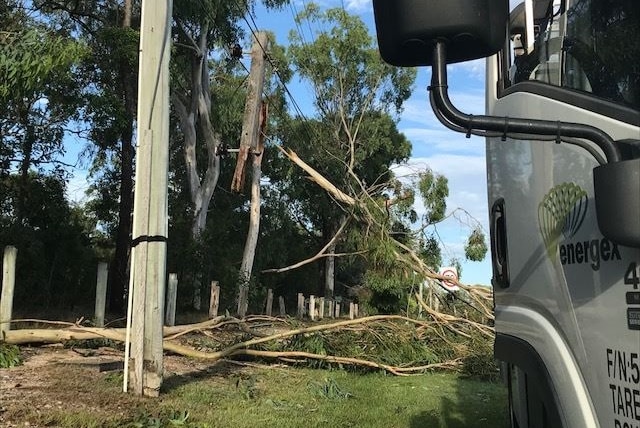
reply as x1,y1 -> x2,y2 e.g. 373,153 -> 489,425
285,3 -> 416,295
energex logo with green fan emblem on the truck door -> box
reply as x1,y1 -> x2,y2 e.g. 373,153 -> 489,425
538,183 -> 620,271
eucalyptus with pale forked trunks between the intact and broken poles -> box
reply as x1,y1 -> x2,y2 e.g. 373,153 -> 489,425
171,0 -> 288,240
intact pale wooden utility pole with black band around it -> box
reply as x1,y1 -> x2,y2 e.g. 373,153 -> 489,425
124,0 -> 172,397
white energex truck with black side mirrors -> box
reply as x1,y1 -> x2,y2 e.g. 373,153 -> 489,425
373,0 -> 640,428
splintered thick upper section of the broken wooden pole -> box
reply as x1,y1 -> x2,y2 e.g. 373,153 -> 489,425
231,31 -> 269,192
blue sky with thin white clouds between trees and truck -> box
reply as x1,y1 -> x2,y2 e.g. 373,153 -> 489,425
246,0 -> 491,285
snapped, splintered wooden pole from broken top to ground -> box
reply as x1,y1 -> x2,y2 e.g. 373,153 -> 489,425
231,31 -> 269,317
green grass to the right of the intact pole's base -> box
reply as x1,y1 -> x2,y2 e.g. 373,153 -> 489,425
142,369 -> 508,428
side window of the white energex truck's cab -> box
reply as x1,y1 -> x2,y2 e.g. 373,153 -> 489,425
511,0 -> 640,110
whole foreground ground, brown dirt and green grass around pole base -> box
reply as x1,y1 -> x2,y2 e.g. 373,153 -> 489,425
0,365 -> 508,428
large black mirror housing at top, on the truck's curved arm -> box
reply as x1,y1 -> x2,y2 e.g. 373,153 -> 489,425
373,0 -> 509,67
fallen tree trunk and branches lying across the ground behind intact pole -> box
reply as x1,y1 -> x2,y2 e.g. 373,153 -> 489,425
4,302 -> 498,376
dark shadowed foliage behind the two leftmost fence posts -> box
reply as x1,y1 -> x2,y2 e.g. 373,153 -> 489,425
0,173 -> 97,310
